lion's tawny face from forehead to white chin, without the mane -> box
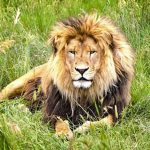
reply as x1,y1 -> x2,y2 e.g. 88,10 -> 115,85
65,36 -> 100,88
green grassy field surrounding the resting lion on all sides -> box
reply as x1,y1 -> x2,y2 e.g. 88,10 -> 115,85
0,0 -> 150,150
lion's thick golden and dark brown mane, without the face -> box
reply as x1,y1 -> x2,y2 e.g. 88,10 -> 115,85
27,14 -> 134,123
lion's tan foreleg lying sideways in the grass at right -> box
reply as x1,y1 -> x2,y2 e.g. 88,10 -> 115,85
74,115 -> 113,133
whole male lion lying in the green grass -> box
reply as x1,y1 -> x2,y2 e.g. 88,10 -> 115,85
0,14 -> 134,139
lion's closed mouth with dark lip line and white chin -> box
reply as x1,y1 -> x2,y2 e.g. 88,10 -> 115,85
73,77 -> 92,89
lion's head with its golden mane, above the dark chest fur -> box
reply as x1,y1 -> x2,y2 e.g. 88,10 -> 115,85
43,14 -> 133,102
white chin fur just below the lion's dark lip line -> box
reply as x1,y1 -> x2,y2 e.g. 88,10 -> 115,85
73,81 -> 92,89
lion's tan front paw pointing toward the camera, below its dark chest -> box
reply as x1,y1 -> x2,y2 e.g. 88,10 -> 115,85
55,118 -> 73,140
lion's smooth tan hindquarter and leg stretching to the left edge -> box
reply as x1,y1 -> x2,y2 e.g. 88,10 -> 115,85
0,63 -> 47,101
